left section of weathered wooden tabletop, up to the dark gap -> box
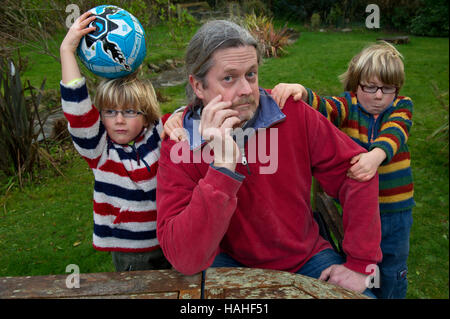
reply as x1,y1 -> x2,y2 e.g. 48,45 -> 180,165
0,270 -> 201,298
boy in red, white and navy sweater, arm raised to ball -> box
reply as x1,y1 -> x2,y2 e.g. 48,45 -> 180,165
60,12 -> 171,271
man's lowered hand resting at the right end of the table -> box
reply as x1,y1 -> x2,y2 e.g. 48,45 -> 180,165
319,265 -> 368,293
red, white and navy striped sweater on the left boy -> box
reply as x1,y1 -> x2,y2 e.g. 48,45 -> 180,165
61,79 -> 163,252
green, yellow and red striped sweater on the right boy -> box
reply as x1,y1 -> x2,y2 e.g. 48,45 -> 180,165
306,88 -> 415,213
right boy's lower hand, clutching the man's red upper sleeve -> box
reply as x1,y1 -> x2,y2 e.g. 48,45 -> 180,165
347,148 -> 386,182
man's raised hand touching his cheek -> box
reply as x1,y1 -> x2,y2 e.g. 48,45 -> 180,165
199,94 -> 241,171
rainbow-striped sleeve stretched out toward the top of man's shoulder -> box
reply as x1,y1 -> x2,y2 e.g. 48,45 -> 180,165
306,88 -> 356,128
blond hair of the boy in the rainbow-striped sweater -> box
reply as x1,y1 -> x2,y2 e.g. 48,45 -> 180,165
339,41 -> 405,92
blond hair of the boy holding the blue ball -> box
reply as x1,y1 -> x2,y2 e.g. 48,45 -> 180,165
94,73 -> 161,125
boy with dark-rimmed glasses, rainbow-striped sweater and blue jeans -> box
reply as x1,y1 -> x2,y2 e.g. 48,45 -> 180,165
272,42 -> 415,298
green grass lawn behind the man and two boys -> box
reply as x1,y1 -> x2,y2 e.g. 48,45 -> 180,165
0,25 -> 449,298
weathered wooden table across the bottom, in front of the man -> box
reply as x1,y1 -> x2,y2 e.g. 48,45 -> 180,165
0,268 -> 367,299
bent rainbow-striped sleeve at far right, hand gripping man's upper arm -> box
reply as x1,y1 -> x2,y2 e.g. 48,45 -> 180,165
369,97 -> 413,163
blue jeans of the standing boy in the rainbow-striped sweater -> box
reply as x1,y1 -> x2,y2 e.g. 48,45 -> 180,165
372,210 -> 413,299
